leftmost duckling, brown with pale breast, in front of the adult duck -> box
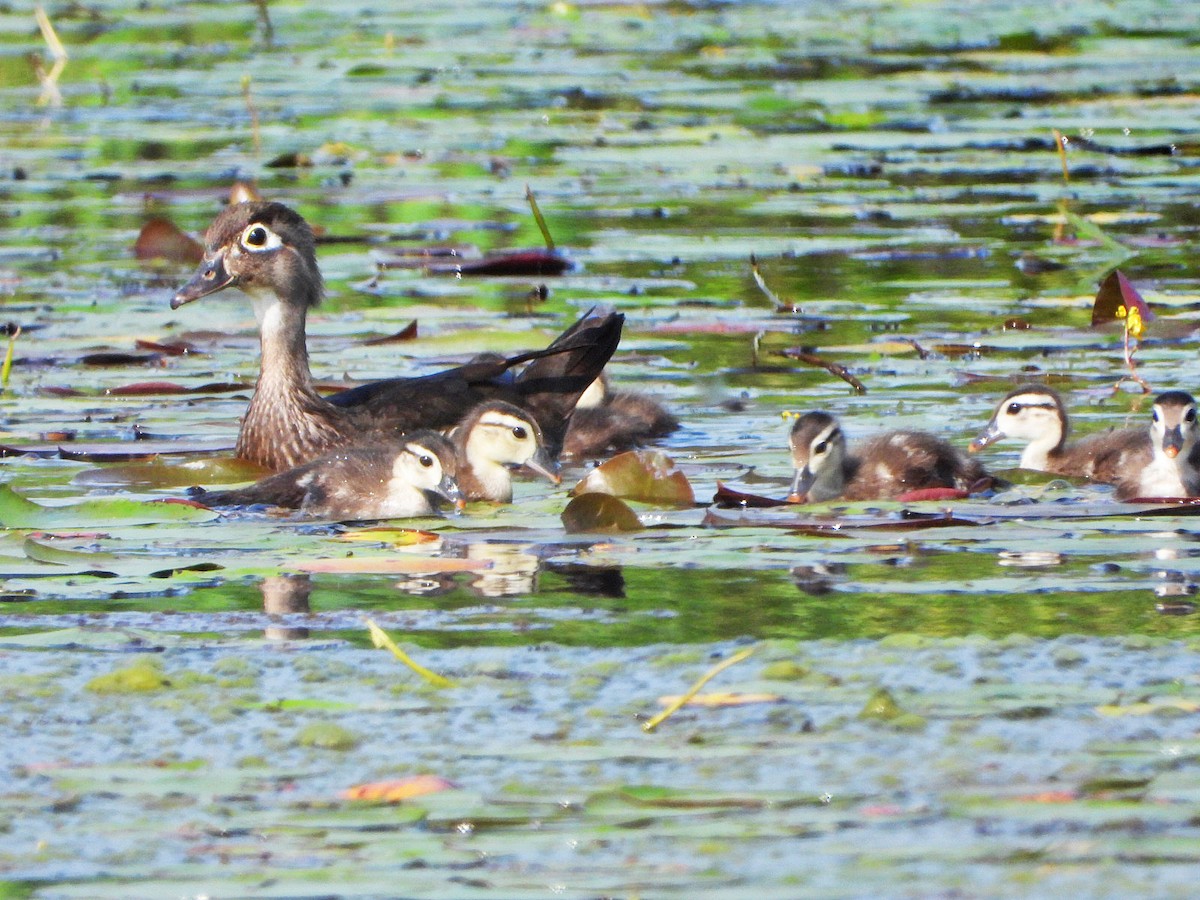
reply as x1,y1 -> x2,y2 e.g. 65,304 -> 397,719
190,431 -> 462,520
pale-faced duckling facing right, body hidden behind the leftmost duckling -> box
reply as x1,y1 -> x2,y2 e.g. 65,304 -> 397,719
450,400 -> 563,503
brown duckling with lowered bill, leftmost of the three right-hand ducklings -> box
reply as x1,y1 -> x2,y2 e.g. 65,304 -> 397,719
788,412 -> 988,502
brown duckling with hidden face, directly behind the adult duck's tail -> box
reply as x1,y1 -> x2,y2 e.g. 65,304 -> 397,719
563,373 -> 679,460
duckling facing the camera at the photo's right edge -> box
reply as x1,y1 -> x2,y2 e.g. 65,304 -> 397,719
1112,391 -> 1200,500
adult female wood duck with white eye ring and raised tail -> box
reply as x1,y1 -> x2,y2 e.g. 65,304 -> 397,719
170,200 -> 624,472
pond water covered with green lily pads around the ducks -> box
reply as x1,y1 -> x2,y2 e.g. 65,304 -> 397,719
0,0 -> 1200,898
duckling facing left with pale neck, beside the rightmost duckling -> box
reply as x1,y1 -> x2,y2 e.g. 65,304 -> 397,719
970,384 -> 1151,482
